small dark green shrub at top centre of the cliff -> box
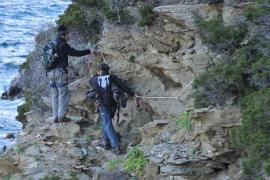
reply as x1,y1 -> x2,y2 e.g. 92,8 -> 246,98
139,6 -> 157,26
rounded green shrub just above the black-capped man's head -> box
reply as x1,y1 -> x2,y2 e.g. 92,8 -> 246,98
57,4 -> 87,27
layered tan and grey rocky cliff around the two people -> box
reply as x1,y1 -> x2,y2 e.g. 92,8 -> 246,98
0,0 -> 255,180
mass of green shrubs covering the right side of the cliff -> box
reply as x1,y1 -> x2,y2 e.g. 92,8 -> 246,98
193,0 -> 270,179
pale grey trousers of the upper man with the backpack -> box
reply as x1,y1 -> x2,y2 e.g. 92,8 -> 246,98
48,69 -> 69,119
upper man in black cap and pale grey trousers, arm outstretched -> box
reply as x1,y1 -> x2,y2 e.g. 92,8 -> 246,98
47,25 -> 96,123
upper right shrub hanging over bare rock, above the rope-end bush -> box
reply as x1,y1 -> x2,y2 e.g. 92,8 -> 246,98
194,13 -> 247,53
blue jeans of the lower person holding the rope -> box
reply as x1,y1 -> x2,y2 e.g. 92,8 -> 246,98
99,105 -> 119,148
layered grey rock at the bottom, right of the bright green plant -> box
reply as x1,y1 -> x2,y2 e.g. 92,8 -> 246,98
148,142 -> 235,179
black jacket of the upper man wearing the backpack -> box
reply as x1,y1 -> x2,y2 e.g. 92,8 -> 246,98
56,37 -> 91,69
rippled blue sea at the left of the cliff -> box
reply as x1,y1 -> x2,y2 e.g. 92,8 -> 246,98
0,0 -> 71,151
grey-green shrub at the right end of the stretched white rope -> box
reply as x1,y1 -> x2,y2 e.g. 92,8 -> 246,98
193,63 -> 242,108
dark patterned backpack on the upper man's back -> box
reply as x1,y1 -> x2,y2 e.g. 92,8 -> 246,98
42,41 -> 58,72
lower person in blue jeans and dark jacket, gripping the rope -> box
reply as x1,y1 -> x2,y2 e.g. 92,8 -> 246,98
90,63 -> 138,154
